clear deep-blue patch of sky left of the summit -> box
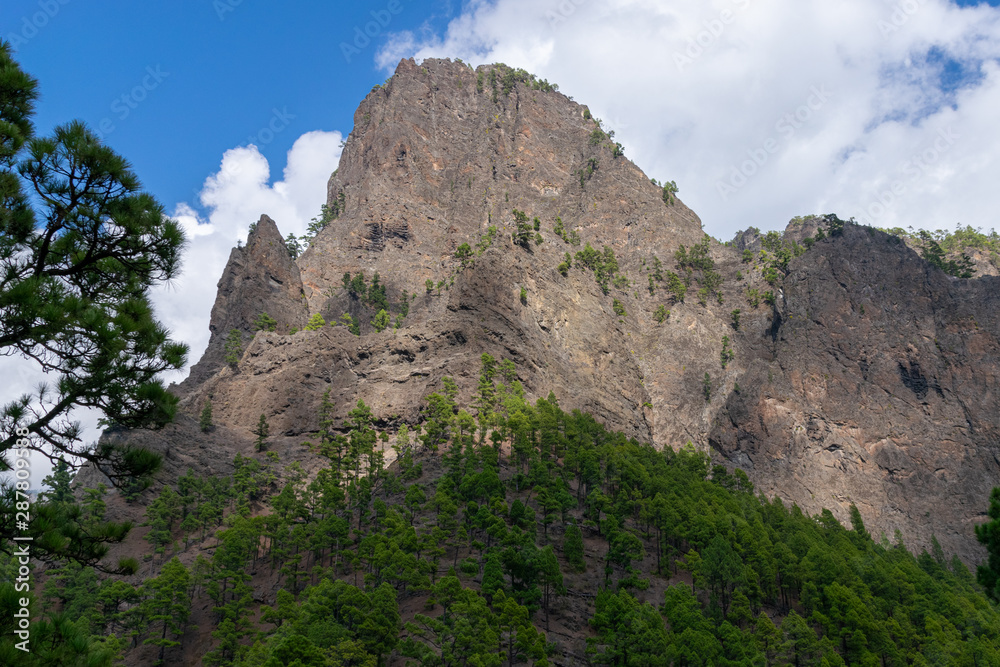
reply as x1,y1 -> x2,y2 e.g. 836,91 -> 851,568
0,0 -> 450,214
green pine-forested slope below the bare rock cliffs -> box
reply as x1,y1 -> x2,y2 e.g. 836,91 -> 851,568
4,355 -> 1000,667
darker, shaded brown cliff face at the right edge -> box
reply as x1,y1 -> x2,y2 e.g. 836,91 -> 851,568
709,226 -> 1000,561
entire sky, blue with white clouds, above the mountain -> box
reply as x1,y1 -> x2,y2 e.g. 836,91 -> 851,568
0,0 -> 1000,480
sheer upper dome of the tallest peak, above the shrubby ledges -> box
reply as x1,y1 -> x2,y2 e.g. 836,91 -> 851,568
299,59 -> 702,311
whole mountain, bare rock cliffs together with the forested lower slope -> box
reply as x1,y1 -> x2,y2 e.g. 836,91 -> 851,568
53,53 -> 1000,665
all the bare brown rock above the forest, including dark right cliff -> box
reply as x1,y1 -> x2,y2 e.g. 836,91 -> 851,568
119,60 -> 1000,561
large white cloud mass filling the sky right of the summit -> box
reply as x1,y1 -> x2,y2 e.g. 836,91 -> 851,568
376,0 -> 1000,238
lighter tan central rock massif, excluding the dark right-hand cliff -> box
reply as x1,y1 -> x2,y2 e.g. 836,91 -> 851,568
176,60 -> 752,454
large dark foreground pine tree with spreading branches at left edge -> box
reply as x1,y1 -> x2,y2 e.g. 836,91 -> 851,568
0,42 -> 187,562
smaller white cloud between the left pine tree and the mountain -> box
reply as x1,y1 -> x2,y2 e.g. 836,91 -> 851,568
153,131 -> 343,381
